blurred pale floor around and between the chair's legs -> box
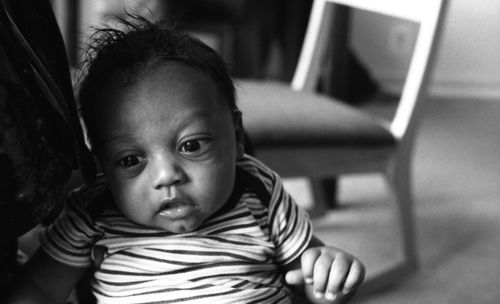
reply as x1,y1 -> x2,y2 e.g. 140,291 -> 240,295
288,99 -> 500,304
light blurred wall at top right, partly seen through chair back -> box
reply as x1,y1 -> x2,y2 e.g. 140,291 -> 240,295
352,0 -> 500,100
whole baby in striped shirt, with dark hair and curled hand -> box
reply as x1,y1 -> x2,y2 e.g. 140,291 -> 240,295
4,17 -> 365,304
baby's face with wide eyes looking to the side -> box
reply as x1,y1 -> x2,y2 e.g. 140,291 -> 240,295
96,62 -> 243,233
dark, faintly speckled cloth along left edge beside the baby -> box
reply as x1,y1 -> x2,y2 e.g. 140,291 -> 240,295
0,0 -> 94,291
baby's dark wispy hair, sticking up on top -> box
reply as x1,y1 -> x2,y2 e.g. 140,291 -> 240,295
78,15 -> 237,145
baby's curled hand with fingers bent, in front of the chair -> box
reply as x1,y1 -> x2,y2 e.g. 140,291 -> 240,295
285,246 -> 365,302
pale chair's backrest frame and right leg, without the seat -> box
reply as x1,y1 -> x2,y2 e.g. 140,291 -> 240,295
291,0 -> 446,292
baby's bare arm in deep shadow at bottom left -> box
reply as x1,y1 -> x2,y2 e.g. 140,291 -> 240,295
6,250 -> 86,304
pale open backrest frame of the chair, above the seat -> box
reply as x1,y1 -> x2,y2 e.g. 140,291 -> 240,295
292,0 -> 447,138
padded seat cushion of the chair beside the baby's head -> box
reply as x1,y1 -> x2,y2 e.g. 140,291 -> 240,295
237,80 -> 396,148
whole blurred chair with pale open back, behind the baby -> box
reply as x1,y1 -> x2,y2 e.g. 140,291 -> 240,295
238,0 -> 446,291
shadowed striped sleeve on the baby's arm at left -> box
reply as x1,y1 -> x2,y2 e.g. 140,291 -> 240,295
40,189 -> 101,267
